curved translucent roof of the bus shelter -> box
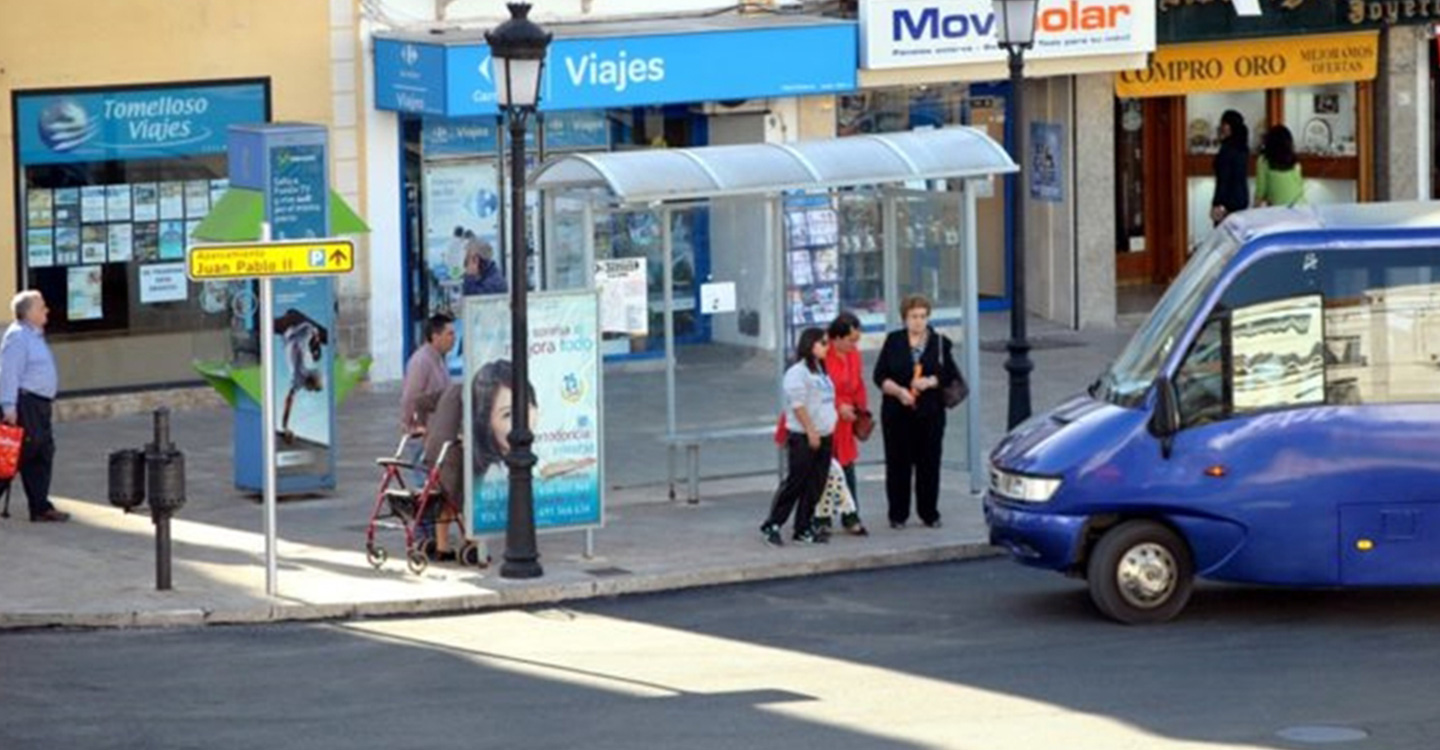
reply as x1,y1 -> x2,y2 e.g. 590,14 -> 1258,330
530,127 -> 1018,203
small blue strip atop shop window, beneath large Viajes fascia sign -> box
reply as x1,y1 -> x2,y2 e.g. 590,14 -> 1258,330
420,111 -> 611,157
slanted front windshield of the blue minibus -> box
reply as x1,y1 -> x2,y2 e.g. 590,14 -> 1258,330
1090,227 -> 1240,407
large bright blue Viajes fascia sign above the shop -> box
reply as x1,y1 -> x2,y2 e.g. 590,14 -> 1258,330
374,22 -> 858,117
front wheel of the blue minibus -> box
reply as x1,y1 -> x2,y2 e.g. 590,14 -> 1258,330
1086,521 -> 1195,625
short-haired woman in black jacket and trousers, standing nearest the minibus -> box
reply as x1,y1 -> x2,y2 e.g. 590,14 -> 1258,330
874,295 -> 956,528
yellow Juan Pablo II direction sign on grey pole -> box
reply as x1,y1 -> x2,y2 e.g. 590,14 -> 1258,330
187,238 -> 356,281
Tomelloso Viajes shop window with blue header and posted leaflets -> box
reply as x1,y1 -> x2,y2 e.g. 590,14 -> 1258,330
12,79 -> 269,393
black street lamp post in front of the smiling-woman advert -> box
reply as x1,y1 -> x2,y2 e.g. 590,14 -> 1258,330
485,3 -> 550,579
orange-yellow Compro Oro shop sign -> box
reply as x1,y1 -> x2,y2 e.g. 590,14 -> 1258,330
1115,32 -> 1380,96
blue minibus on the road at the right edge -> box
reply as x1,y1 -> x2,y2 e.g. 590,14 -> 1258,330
985,203 -> 1440,623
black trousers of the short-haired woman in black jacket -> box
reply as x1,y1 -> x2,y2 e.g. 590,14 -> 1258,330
880,403 -> 945,524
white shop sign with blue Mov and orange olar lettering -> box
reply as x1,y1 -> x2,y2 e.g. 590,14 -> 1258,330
860,0 -> 1155,69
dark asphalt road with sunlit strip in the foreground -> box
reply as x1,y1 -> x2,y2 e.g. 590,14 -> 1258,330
0,560 -> 1440,750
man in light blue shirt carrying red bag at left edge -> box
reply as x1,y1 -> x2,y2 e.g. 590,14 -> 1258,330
0,289 -> 71,523
